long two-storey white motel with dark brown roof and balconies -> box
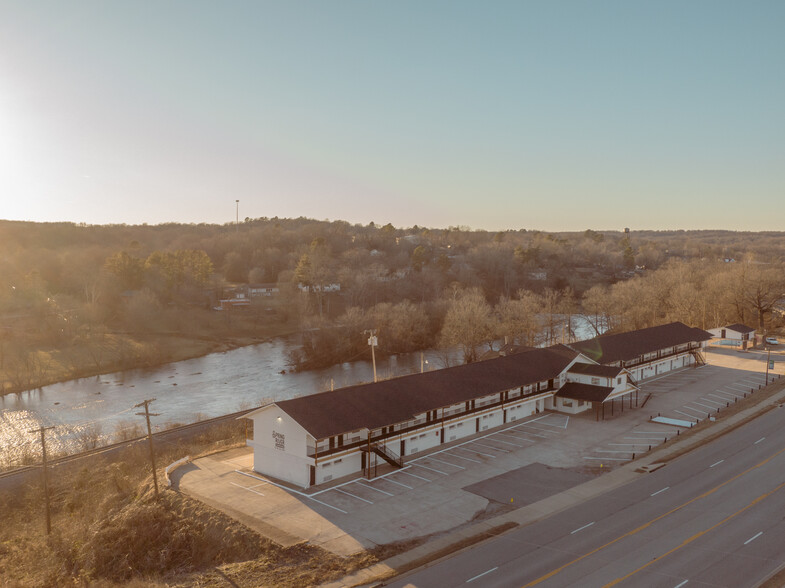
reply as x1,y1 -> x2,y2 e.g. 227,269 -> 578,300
242,323 -> 711,488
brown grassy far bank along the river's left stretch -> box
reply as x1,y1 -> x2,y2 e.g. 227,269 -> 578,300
0,322 -> 297,396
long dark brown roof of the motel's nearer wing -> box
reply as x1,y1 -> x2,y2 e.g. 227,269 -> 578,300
276,345 -> 578,439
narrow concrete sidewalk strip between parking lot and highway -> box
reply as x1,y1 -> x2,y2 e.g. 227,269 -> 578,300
323,380 -> 785,588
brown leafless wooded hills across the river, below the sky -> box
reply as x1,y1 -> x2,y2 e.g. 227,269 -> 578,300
0,218 -> 785,391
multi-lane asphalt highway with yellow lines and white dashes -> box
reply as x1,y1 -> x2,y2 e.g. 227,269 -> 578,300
389,408 -> 785,588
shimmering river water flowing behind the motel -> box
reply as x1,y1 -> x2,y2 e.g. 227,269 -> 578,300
0,314 -> 591,467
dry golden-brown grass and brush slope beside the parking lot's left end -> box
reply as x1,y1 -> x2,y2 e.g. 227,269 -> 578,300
0,424 -> 413,588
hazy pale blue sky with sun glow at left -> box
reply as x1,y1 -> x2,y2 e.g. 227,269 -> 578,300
0,0 -> 785,230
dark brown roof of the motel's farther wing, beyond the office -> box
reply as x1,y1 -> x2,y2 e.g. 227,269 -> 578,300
570,322 -> 712,364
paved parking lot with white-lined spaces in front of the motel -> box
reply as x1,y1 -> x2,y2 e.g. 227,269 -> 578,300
174,354 -> 780,555
